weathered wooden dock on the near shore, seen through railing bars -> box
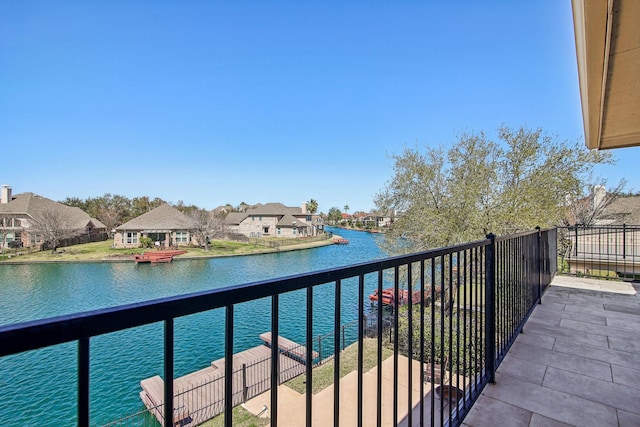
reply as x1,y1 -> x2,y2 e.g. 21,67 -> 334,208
140,332 -> 317,426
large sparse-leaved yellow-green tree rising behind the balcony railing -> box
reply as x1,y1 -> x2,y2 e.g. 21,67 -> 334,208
375,126 -> 611,253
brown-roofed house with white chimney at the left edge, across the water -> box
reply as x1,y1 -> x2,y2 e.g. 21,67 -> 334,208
0,185 -> 107,251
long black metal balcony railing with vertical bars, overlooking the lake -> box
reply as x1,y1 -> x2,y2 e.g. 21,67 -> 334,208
0,229 -> 557,426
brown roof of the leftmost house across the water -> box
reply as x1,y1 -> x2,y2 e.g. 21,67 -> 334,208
0,193 -> 101,229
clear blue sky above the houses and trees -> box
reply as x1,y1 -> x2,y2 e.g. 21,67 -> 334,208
0,0 -> 640,212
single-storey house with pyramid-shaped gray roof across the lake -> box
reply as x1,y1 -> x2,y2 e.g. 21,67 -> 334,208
113,203 -> 197,248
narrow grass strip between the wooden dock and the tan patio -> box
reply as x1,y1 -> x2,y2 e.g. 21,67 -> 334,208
285,338 -> 393,394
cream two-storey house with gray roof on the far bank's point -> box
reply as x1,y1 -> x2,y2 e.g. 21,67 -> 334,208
225,203 -> 324,238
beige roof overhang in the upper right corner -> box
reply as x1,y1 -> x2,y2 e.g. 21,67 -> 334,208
572,0 -> 640,150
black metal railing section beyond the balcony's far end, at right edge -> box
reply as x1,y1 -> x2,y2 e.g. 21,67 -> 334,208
558,224 -> 640,279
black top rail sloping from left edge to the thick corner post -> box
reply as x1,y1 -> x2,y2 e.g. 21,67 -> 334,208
0,239 -> 490,357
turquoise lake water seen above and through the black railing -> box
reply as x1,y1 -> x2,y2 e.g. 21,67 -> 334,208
0,230 -> 384,426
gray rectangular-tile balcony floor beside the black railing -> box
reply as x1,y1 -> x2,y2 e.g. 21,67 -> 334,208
463,276 -> 640,427
